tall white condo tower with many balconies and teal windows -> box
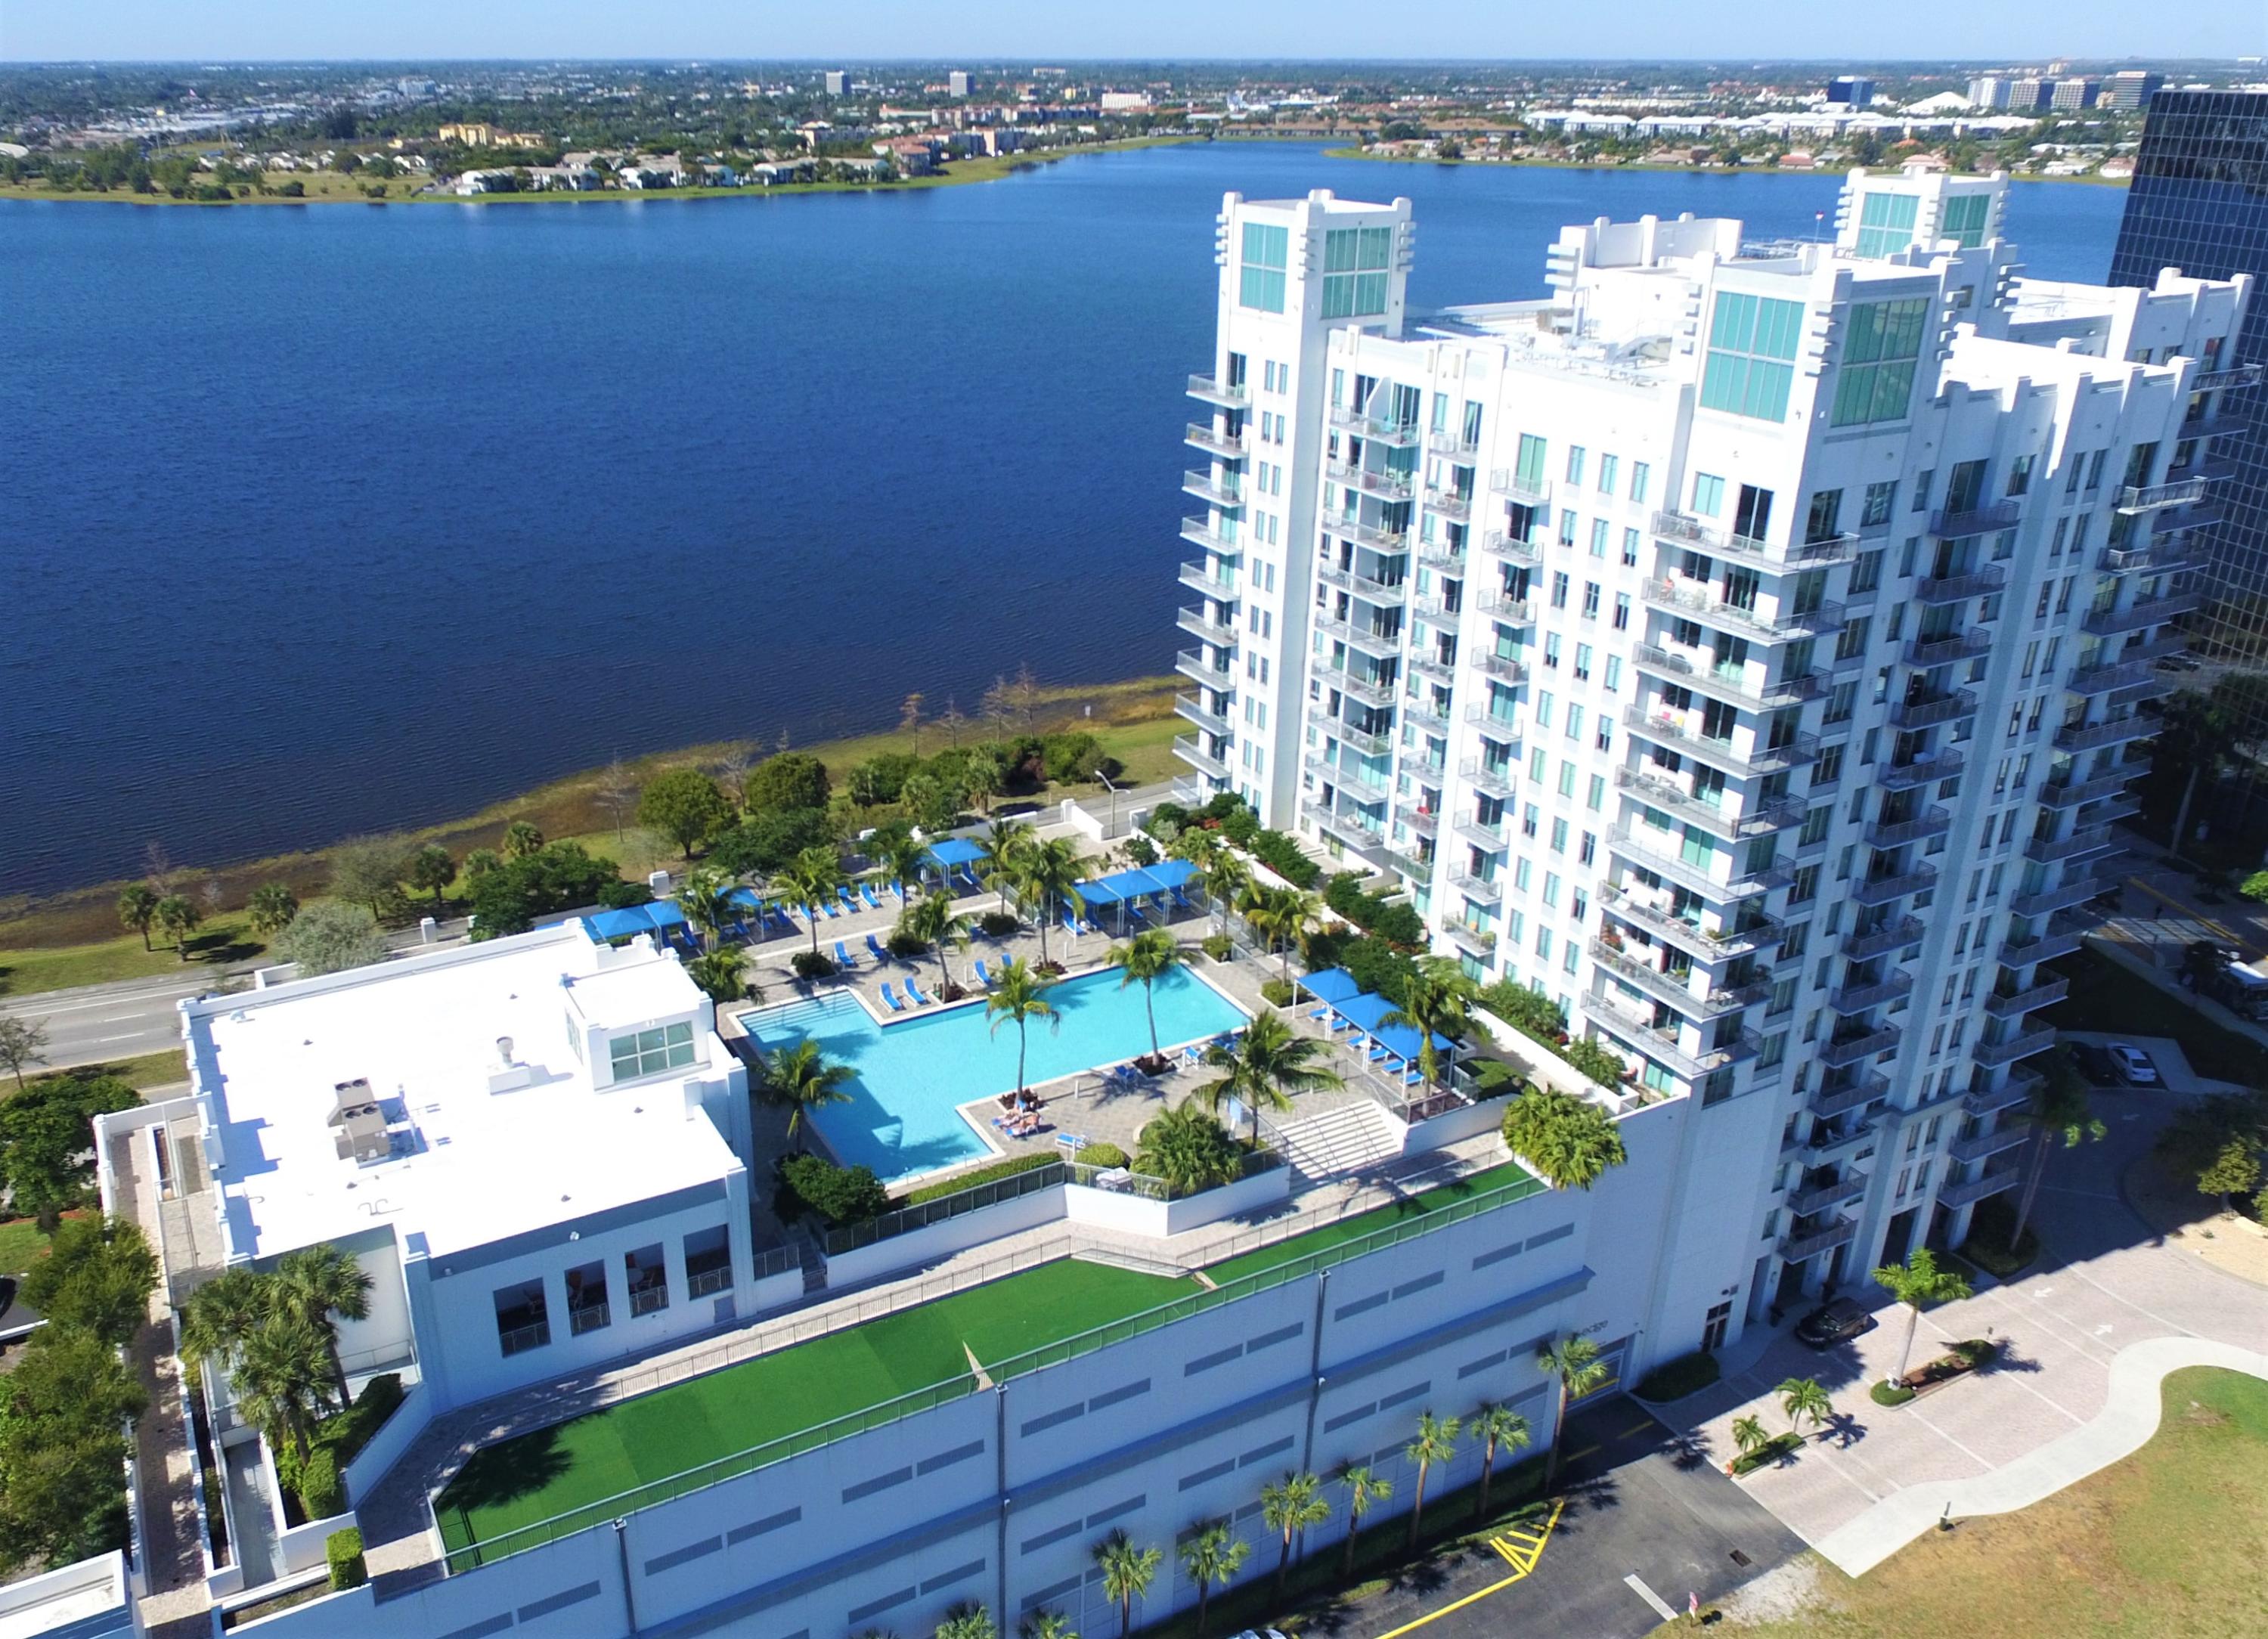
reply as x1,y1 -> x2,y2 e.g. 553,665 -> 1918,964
1179,170 -> 2250,1317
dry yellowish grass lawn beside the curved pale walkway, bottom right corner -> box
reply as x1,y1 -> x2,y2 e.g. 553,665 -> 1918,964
1706,1367 -> 2268,1639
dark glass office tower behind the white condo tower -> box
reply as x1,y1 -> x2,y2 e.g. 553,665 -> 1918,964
2112,91 -> 2268,770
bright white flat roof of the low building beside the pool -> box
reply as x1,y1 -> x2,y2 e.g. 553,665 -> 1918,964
181,922 -> 739,1258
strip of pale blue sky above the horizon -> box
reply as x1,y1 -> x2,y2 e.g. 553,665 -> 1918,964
0,0 -> 2268,61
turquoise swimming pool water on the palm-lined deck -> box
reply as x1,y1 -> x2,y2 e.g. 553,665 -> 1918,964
739,968 -> 1245,1183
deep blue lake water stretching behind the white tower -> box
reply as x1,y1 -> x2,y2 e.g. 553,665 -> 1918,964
0,143 -> 2123,893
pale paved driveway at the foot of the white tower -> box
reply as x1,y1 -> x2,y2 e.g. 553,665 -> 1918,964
1665,1092 -> 2268,1569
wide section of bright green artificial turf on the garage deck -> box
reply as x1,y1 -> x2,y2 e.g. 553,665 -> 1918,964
435,1258 -> 1200,1551
